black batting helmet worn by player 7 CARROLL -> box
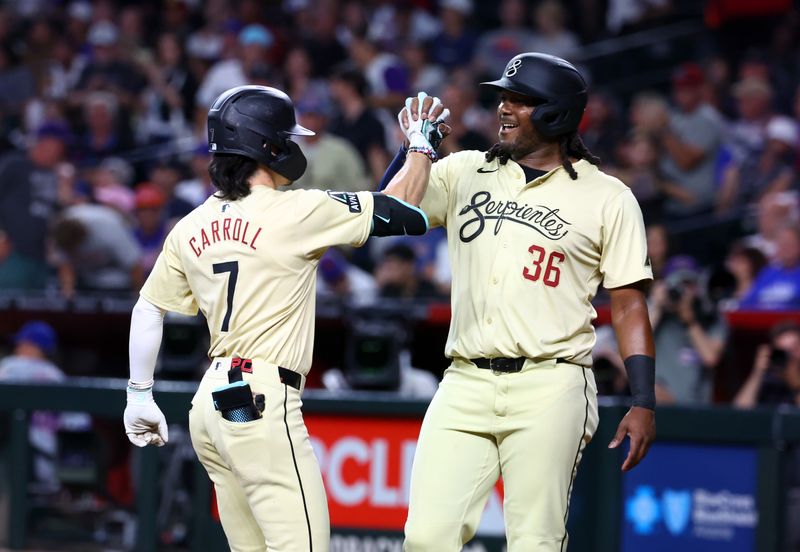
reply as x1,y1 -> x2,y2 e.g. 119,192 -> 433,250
208,86 -> 314,180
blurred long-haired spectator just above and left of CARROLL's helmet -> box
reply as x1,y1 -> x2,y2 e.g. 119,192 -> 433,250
137,32 -> 197,144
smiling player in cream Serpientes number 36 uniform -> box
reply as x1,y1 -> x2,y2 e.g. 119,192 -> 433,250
404,53 -> 655,552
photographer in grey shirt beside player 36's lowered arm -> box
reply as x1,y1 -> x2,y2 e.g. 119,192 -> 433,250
649,255 -> 727,404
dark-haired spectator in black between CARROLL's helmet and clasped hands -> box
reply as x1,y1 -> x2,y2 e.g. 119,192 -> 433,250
329,66 -> 389,182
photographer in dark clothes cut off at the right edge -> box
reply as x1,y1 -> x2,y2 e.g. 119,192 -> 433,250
733,322 -> 800,408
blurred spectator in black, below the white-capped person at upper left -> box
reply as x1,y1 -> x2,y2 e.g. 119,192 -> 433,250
75,91 -> 133,167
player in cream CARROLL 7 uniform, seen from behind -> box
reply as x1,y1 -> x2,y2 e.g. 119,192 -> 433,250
124,86 -> 446,552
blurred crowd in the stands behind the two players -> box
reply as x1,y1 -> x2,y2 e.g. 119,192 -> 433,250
0,0 -> 800,405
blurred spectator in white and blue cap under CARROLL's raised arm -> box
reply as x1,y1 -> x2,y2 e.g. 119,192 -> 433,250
317,249 -> 378,306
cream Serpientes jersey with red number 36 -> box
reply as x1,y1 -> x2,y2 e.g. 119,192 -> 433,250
421,151 -> 652,366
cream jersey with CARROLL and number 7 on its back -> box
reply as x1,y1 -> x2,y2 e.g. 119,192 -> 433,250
141,186 -> 373,375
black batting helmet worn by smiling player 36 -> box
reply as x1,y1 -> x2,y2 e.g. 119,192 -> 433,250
481,52 -> 586,138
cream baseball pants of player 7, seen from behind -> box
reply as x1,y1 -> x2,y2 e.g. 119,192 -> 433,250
189,358 -> 330,552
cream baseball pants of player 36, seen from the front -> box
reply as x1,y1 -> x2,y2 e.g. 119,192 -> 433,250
403,359 -> 598,552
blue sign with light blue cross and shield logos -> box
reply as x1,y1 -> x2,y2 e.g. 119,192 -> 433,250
622,443 -> 758,552
